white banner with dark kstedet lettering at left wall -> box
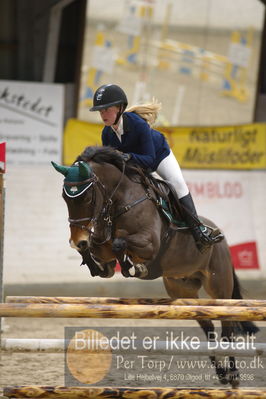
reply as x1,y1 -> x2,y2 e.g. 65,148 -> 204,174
0,80 -> 64,165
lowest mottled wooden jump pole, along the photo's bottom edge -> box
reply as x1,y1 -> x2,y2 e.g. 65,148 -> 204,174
3,385 -> 266,399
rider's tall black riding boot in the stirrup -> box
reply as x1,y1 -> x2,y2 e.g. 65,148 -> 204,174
179,193 -> 224,252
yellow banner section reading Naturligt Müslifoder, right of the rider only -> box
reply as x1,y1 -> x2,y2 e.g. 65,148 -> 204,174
159,124 -> 266,169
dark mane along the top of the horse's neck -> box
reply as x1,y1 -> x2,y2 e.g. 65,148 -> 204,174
75,146 -> 140,177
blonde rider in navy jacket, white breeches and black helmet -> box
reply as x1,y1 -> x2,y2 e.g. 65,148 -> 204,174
90,84 -> 223,252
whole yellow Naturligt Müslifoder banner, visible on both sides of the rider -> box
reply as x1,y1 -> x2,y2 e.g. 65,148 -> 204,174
64,119 -> 266,170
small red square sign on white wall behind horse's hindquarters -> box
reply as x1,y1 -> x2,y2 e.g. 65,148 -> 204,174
230,241 -> 259,269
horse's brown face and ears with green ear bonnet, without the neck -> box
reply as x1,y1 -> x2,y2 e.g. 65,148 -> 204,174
52,161 -> 97,252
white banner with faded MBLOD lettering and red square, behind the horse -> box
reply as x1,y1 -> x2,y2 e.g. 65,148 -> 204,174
184,170 -> 261,269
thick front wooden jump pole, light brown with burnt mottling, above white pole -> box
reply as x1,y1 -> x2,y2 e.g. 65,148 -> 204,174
0,303 -> 266,321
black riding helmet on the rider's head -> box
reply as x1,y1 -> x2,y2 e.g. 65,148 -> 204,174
90,84 -> 128,113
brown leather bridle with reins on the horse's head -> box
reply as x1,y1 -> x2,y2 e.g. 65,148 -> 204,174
64,162 -> 151,245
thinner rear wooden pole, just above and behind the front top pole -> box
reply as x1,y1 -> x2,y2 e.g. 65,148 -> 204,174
6,296 -> 266,307
